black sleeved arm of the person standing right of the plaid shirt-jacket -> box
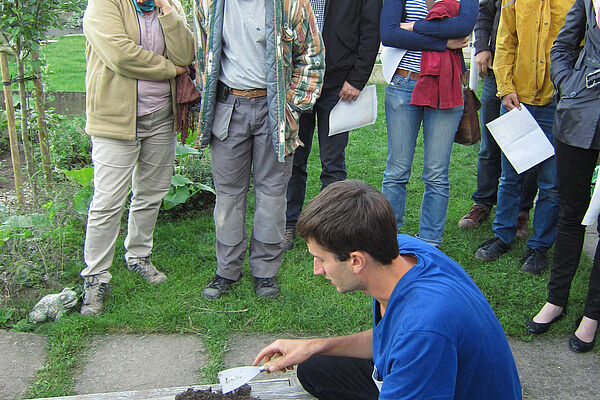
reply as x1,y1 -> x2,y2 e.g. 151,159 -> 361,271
342,0 -> 383,91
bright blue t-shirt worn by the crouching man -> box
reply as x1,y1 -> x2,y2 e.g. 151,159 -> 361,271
373,235 -> 522,400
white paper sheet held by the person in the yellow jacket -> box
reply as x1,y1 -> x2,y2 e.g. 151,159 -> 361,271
487,104 -> 554,174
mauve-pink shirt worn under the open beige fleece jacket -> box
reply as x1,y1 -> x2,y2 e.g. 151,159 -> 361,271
137,9 -> 171,116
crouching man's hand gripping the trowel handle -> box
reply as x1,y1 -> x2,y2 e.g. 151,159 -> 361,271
254,339 -> 316,372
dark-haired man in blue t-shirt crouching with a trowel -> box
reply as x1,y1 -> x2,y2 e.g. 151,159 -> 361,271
254,181 -> 522,400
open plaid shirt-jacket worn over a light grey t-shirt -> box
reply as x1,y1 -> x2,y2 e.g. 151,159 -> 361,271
193,0 -> 325,162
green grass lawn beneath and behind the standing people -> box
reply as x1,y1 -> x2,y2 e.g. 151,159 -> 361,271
0,38 -> 591,397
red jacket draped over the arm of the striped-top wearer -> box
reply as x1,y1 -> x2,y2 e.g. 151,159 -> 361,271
410,0 -> 463,109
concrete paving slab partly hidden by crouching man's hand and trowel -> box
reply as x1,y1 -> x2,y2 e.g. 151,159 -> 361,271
223,333 -> 310,380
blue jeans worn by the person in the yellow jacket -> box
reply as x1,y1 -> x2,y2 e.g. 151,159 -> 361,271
492,103 -> 559,251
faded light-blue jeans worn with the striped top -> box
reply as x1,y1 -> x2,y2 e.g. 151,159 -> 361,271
381,75 -> 463,245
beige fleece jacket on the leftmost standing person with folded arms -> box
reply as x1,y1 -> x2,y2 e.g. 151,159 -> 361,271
83,0 -> 194,140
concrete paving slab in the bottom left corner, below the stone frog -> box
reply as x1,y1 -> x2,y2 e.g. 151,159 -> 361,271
0,330 -> 46,400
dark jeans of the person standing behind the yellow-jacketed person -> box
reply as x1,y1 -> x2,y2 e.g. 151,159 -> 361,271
471,74 -> 537,211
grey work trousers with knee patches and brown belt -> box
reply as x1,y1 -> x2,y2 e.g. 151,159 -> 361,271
210,93 -> 292,281
